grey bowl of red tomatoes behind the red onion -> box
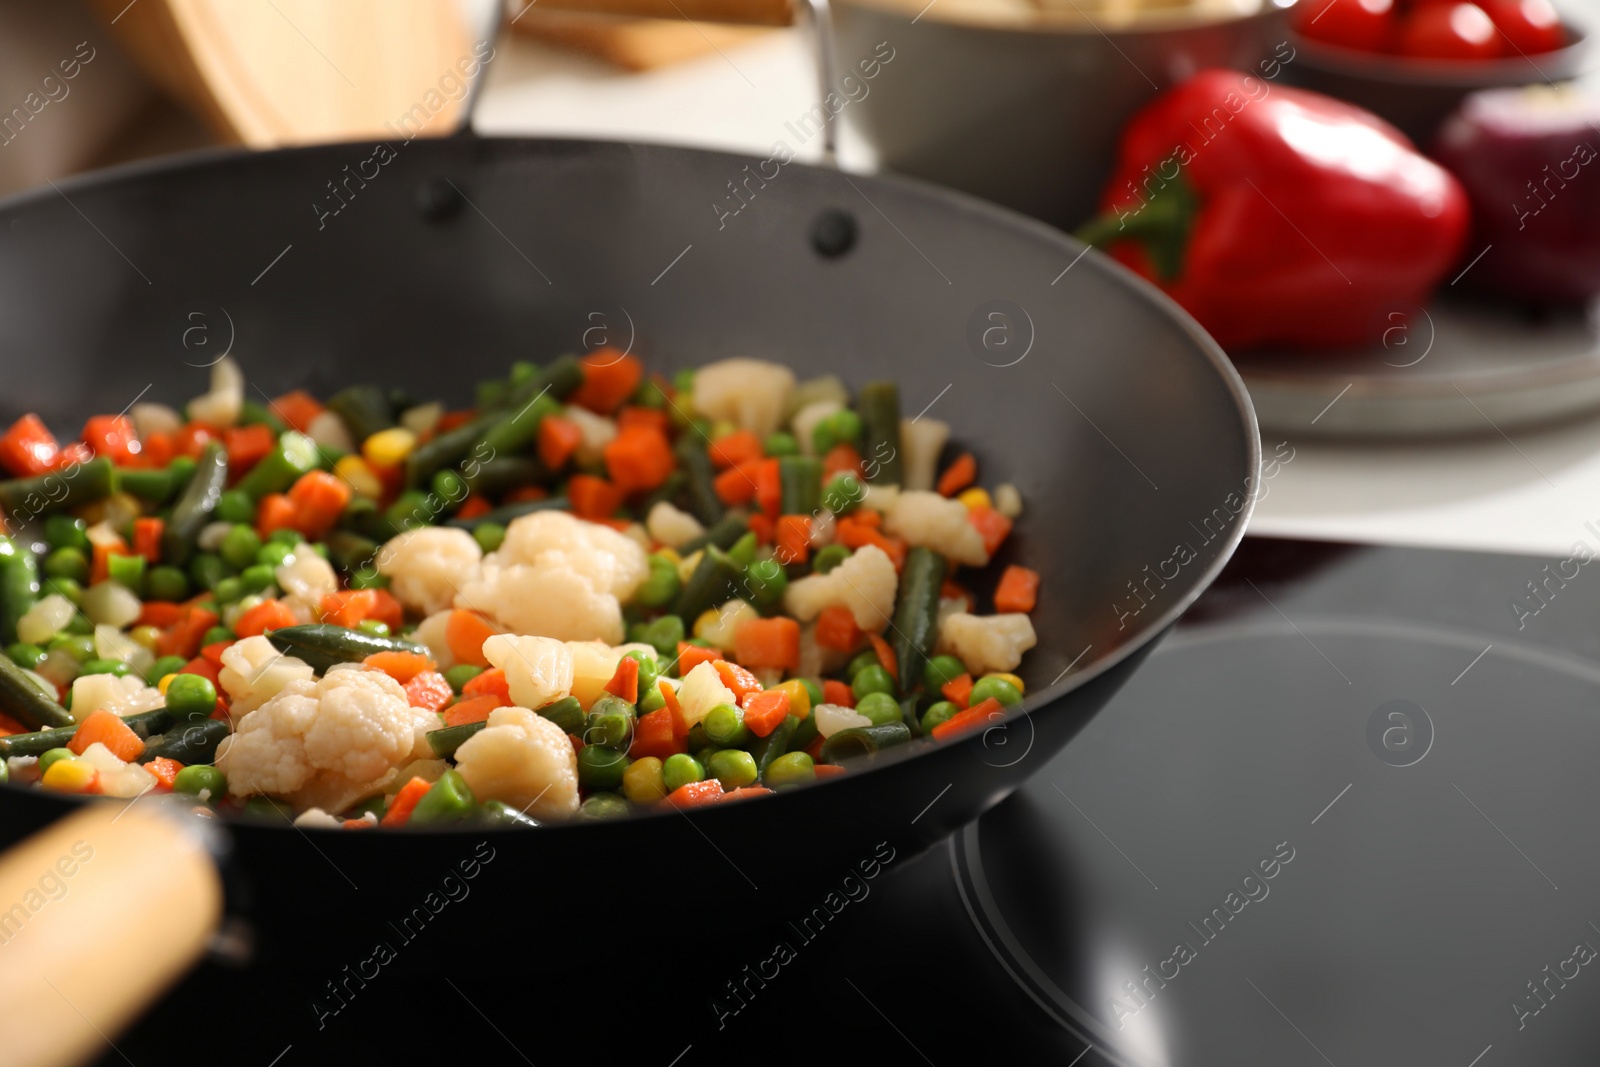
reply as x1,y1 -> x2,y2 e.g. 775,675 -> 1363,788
1286,0 -> 1589,147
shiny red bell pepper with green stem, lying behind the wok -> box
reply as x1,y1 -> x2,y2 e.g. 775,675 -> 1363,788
1080,70 -> 1467,349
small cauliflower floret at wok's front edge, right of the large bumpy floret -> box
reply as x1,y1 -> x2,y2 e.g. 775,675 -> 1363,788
456,707 -> 578,819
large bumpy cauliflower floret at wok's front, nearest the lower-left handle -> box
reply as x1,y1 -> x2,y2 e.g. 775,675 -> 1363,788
216,671 -> 418,811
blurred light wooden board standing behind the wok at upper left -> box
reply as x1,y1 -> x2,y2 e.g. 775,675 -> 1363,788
90,0 -> 473,149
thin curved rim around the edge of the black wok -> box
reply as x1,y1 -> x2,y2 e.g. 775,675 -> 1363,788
0,131 -> 1262,840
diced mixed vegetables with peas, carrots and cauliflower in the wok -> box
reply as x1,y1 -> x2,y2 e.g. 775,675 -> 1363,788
0,349 -> 1038,829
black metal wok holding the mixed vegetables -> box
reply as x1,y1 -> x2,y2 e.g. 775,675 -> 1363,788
0,138 -> 1259,1062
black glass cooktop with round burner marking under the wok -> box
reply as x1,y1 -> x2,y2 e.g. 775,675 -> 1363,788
107,533 -> 1600,1067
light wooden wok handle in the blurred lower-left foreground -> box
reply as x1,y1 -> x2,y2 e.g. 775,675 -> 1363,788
0,800 -> 222,1067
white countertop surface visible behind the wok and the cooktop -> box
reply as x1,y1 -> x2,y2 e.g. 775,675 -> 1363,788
475,20 -> 1600,555
